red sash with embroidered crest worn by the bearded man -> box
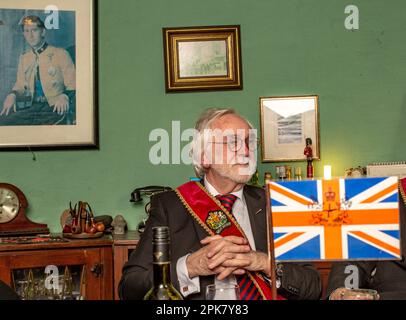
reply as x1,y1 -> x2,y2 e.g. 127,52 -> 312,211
175,181 -> 272,300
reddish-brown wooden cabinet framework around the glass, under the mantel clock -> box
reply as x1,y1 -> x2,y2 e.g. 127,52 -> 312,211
0,237 -> 113,300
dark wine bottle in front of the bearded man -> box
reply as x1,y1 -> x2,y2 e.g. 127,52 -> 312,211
144,227 -> 183,300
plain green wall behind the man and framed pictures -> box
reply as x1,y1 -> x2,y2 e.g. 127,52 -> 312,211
0,0 -> 406,232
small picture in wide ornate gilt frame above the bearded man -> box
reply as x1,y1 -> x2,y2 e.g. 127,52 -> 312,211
163,25 -> 242,92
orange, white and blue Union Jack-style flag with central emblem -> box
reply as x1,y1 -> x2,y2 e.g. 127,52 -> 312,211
268,177 -> 401,261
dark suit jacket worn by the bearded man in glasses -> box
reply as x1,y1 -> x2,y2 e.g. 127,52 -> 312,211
119,186 -> 321,300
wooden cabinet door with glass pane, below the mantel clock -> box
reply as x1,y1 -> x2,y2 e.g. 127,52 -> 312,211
0,244 -> 113,300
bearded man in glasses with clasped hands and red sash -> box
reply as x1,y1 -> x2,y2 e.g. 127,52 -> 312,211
119,109 -> 321,300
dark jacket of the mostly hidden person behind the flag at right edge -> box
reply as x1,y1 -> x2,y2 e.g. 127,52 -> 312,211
326,200 -> 406,300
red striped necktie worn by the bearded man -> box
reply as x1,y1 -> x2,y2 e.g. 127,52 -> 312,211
216,194 -> 262,300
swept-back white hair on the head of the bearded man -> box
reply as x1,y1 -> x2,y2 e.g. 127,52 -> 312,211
190,108 -> 253,178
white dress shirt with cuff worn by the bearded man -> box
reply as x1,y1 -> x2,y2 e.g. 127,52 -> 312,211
176,177 -> 255,300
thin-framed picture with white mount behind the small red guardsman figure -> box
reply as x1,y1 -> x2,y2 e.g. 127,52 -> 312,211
259,95 -> 320,162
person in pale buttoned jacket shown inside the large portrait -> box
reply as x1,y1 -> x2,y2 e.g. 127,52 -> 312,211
0,16 -> 76,125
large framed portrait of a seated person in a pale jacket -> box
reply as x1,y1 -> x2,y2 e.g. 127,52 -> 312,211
0,0 -> 98,150
